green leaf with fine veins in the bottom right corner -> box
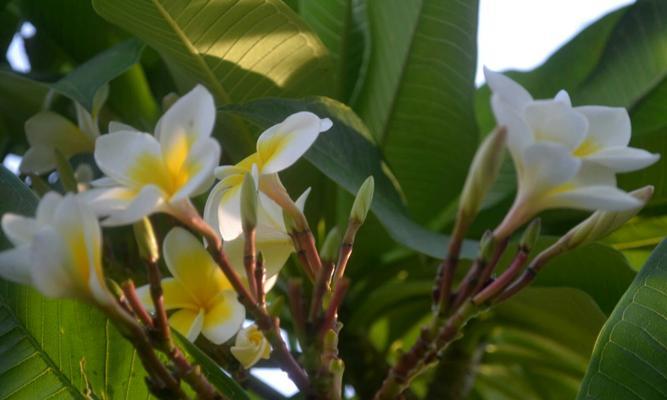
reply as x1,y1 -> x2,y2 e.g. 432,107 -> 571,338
577,241 -> 667,400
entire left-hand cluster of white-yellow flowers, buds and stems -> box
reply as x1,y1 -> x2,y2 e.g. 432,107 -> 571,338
0,86 -> 373,399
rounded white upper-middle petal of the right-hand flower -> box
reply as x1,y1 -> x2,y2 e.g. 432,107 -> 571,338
524,100 -> 588,150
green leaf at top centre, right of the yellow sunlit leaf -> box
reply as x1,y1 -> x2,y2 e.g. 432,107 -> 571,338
299,0 -> 370,100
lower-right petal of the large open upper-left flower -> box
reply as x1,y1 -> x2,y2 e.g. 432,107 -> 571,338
171,138 -> 220,202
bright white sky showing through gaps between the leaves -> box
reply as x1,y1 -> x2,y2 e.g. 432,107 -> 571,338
4,0 -> 634,396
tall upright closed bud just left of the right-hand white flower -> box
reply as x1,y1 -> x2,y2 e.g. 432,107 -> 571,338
459,127 -> 507,225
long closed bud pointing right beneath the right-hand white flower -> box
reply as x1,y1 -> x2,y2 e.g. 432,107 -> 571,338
561,186 -> 653,250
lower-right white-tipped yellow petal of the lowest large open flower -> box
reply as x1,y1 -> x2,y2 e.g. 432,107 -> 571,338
202,290 -> 245,344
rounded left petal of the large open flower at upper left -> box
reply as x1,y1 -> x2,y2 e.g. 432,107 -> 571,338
95,131 -> 164,187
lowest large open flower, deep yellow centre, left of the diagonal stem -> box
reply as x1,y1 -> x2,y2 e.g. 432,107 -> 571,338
137,228 -> 245,344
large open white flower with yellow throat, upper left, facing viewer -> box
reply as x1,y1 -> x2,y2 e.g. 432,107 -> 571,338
85,85 -> 220,226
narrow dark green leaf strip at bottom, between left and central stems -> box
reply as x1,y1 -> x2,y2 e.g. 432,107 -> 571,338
171,330 -> 250,400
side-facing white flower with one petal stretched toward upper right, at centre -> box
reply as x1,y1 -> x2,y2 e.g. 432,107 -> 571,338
204,111 -> 332,241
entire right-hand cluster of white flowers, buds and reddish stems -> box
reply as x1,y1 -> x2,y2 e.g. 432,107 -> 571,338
376,70 -> 659,400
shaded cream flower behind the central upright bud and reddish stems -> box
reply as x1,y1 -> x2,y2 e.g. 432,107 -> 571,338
219,189 -> 310,291
